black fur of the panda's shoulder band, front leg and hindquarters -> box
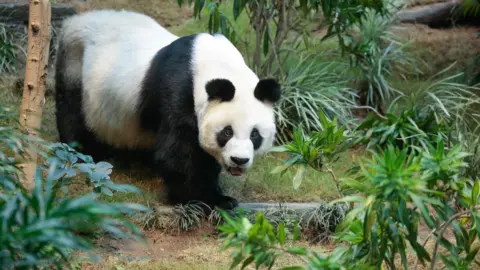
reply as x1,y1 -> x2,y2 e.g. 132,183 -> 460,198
56,35 -> 238,209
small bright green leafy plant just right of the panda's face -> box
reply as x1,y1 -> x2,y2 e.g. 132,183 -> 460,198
272,112 -> 348,195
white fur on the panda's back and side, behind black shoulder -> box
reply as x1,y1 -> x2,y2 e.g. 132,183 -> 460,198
60,10 -> 177,148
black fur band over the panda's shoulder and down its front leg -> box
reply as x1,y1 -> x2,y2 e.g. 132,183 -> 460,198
137,35 -> 238,209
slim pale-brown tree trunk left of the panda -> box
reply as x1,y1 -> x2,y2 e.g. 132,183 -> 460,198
20,0 -> 51,189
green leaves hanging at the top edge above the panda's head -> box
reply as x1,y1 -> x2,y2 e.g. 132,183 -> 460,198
178,0 -> 386,75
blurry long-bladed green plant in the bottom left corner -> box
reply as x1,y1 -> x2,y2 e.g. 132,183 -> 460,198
0,161 -> 146,269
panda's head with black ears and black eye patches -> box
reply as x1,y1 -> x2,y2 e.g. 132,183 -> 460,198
199,77 -> 281,176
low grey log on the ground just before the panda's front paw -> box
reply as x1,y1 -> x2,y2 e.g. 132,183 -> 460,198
144,202 -> 349,241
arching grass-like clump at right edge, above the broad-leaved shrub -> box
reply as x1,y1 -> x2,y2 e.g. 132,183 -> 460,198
355,68 -> 480,151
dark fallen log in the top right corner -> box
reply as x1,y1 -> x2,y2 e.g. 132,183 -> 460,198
396,1 -> 480,28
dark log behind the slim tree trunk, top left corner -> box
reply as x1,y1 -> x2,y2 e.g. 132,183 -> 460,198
0,2 -> 77,24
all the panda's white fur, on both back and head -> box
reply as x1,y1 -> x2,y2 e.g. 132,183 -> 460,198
57,10 -> 275,170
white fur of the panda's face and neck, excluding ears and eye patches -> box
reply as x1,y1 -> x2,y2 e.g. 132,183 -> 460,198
193,34 -> 275,168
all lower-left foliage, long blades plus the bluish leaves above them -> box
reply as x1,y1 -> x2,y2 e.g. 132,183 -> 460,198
0,108 -> 148,269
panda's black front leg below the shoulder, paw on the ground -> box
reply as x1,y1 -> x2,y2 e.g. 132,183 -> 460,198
155,131 -> 238,210
